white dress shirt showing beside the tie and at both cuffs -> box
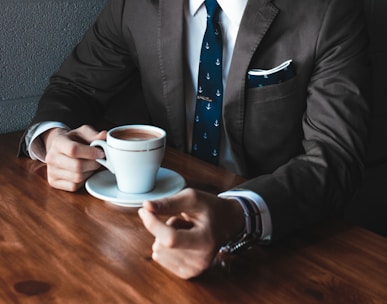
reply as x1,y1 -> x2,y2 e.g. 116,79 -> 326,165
26,0 -> 272,241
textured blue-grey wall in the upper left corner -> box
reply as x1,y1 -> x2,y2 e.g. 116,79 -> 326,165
0,0 -> 106,133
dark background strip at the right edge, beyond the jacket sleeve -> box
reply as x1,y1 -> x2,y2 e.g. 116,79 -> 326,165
346,0 -> 387,236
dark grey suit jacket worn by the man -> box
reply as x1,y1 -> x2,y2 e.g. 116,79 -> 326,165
22,0 -> 369,239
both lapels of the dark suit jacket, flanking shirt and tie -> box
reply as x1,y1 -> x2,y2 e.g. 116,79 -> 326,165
158,0 -> 278,158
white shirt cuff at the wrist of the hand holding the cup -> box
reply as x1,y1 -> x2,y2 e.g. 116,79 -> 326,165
25,121 -> 69,162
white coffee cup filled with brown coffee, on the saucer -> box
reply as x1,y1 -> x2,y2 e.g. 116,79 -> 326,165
90,125 -> 166,194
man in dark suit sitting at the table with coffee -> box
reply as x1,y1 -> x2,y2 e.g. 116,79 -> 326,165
20,0 -> 369,278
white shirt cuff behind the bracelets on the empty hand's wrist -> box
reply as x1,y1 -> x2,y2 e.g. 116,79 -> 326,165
218,189 -> 272,241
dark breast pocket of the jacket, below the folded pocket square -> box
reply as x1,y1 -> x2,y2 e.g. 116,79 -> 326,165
243,77 -> 305,172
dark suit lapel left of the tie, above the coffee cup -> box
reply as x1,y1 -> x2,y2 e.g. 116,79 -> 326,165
155,0 -> 186,149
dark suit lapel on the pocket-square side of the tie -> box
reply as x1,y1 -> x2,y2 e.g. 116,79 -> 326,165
223,0 -> 278,174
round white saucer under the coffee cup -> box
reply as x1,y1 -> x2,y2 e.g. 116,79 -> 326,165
85,168 -> 185,207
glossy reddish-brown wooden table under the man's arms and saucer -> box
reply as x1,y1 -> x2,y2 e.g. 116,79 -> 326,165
0,133 -> 387,304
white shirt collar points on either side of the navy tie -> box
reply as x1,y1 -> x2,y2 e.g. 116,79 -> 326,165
189,0 -> 248,25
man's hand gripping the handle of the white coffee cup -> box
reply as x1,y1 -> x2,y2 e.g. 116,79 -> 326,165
41,125 -> 106,192
